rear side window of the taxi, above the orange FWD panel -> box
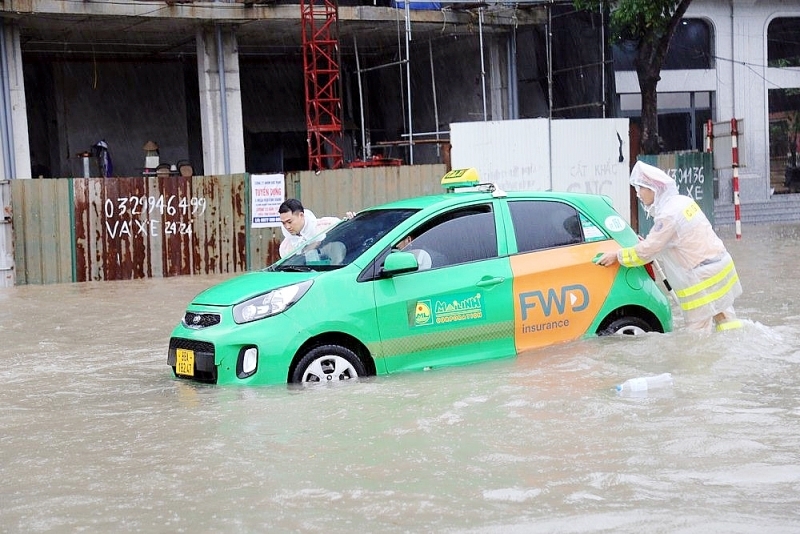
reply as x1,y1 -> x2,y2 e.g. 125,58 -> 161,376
508,200 -> 583,252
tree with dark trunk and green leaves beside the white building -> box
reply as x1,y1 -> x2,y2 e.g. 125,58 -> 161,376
573,0 -> 692,154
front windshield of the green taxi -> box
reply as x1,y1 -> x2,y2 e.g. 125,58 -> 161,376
268,209 -> 417,271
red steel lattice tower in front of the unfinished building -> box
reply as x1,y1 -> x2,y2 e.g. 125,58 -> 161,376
300,0 -> 344,170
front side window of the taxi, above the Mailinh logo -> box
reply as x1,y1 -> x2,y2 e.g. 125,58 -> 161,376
411,204 -> 497,269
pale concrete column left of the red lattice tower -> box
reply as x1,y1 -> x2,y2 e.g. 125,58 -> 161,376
197,25 -> 245,175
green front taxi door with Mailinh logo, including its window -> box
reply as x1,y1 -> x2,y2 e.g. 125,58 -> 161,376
374,202 -> 515,373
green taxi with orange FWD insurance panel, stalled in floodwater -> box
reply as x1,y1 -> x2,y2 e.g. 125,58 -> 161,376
167,169 -> 672,384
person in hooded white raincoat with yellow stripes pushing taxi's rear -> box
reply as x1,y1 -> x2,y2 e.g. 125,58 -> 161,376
597,161 -> 742,331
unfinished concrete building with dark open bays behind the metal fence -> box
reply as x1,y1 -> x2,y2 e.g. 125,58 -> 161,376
0,0 -> 614,178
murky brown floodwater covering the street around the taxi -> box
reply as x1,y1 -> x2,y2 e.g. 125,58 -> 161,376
0,225 -> 800,534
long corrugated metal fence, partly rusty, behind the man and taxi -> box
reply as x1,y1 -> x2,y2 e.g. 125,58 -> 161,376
7,165 -> 446,285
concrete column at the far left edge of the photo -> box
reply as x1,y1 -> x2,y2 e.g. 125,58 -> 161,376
0,22 -> 31,179
